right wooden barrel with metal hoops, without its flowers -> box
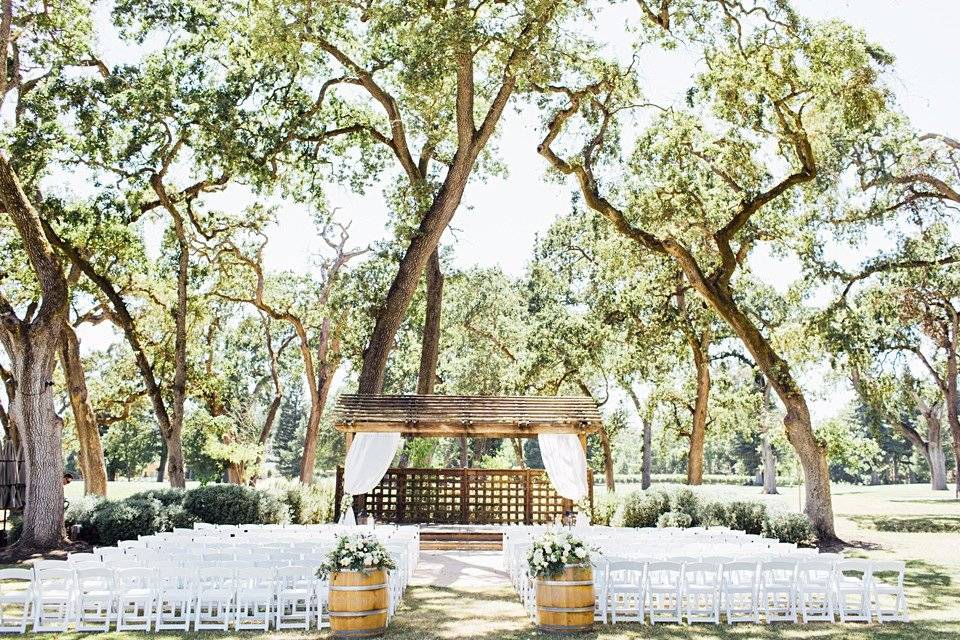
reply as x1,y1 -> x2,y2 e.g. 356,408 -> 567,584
537,565 -> 593,633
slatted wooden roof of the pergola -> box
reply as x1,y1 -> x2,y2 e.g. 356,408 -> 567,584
334,394 -> 602,438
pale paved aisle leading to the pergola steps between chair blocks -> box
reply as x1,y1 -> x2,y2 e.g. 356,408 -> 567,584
411,551 -> 510,591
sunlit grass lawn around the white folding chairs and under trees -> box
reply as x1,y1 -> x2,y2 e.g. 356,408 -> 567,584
18,483 -> 960,640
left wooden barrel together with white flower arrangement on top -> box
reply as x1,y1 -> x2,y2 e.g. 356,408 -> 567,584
317,533 -> 396,638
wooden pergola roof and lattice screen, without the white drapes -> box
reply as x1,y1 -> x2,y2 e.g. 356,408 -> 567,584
334,394 -> 602,524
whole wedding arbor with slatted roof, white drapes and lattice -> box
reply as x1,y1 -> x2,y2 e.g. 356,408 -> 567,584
334,394 -> 601,524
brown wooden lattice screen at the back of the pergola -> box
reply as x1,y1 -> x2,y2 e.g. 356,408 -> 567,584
334,467 -> 593,524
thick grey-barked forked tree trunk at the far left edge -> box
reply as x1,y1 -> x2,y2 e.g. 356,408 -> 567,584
0,154 -> 68,550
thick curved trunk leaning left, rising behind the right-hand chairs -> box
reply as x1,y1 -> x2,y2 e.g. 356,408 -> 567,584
664,248 -> 836,543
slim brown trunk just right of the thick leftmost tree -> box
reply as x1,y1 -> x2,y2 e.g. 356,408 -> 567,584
60,323 -> 107,496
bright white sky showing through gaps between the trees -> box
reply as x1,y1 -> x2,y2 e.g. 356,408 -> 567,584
79,0 -> 960,418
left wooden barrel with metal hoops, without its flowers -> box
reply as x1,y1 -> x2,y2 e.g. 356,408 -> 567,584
329,569 -> 390,638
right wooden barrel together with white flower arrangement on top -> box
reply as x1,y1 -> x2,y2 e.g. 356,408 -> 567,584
527,530 -> 594,633
